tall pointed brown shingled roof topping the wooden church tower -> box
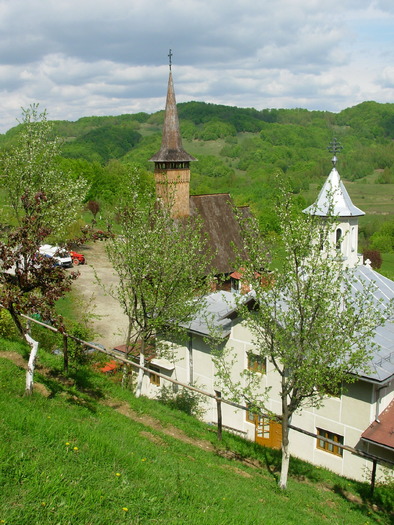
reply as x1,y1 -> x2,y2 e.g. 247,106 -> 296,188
149,71 -> 196,162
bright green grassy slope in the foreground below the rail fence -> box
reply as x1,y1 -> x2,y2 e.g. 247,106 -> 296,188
0,340 -> 390,525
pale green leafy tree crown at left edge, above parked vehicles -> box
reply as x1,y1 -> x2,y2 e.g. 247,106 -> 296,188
1,105 -> 87,240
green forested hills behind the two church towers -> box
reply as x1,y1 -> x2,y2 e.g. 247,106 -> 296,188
0,102 -> 394,247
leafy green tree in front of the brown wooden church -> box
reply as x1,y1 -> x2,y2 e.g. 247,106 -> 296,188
104,170 -> 212,389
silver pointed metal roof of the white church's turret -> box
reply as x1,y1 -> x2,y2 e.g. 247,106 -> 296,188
304,167 -> 365,217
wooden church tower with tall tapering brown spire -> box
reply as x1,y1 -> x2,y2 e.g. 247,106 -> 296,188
149,51 -> 196,217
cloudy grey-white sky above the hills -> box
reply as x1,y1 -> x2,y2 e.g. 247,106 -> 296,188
0,0 -> 394,133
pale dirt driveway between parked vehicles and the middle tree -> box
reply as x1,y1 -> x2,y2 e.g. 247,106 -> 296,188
69,241 -> 127,350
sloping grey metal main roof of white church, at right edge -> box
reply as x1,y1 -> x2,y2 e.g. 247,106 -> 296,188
353,266 -> 394,382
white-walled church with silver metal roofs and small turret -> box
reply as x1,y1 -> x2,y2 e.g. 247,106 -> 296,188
140,157 -> 394,480
